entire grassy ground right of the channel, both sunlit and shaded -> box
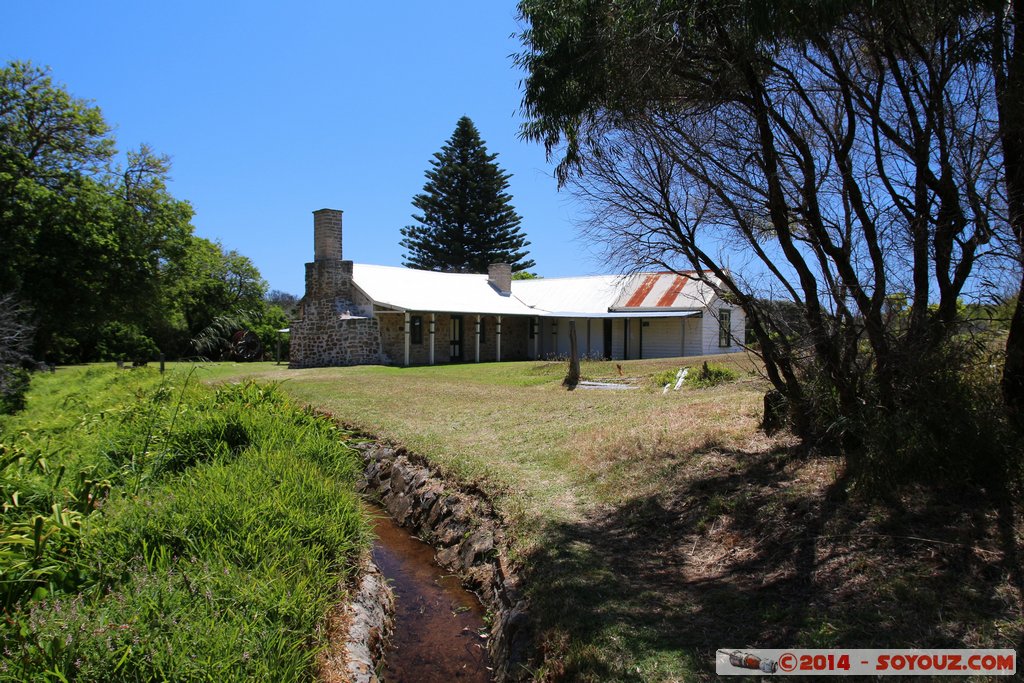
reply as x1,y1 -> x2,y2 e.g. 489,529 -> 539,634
204,356 -> 1024,681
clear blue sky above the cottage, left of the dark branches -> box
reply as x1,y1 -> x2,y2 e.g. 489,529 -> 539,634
0,0 -> 602,295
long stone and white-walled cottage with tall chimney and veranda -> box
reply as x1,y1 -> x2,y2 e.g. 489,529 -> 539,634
291,209 -> 744,368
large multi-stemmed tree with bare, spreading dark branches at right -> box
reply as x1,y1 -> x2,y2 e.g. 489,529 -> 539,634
518,0 -> 1015,471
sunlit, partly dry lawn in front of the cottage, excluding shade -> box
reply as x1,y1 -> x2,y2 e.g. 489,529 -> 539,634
188,354 -> 765,550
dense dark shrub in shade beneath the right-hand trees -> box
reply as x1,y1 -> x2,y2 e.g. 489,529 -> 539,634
774,335 -> 1024,496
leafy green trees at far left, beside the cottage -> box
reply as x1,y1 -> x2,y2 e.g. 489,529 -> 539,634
0,61 -> 296,362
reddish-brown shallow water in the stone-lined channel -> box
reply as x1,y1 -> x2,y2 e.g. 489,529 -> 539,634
368,505 -> 490,683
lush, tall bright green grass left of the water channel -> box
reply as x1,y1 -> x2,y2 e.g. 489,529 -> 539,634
0,368 -> 369,681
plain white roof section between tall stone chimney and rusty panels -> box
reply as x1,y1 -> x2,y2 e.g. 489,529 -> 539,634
352,263 -> 537,315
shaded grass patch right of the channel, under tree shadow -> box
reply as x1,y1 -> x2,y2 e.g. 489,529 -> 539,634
524,451 -> 1024,681
